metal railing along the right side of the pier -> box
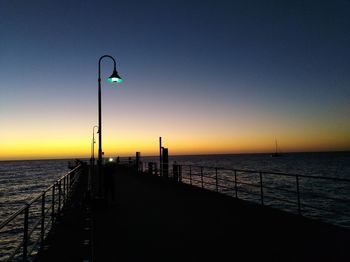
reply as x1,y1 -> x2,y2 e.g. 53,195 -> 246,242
143,163 -> 350,228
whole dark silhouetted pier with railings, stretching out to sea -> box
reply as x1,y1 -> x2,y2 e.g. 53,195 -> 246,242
0,161 -> 350,262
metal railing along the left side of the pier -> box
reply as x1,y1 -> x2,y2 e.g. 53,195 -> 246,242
0,165 -> 82,261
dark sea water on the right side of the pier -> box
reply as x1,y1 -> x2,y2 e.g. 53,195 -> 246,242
143,152 -> 350,228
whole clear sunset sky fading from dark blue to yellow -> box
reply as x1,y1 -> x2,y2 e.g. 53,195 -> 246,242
0,0 -> 350,160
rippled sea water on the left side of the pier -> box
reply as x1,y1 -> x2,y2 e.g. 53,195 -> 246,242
0,160 -> 69,261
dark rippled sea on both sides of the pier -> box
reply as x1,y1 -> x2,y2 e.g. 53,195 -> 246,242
0,152 -> 350,261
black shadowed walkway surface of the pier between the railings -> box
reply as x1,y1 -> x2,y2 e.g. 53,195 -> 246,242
37,167 -> 350,261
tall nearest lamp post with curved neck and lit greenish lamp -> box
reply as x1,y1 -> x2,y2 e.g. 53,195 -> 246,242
97,55 -> 123,196
